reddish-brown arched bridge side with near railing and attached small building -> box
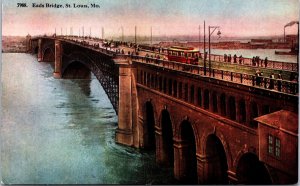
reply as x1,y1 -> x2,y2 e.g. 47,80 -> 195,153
28,37 -> 298,184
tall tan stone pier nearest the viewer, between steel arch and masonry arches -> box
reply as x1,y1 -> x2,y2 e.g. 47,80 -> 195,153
115,59 -> 139,147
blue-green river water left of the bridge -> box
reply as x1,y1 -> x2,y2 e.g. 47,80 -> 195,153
0,53 -> 176,184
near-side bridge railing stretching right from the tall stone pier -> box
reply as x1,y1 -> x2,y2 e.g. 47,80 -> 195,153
131,56 -> 299,95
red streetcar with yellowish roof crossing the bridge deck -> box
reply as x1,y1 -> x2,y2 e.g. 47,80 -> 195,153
168,46 -> 199,65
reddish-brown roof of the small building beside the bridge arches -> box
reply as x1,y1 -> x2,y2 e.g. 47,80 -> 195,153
254,110 -> 298,134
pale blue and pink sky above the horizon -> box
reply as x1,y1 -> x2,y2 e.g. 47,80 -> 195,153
2,0 -> 299,37
